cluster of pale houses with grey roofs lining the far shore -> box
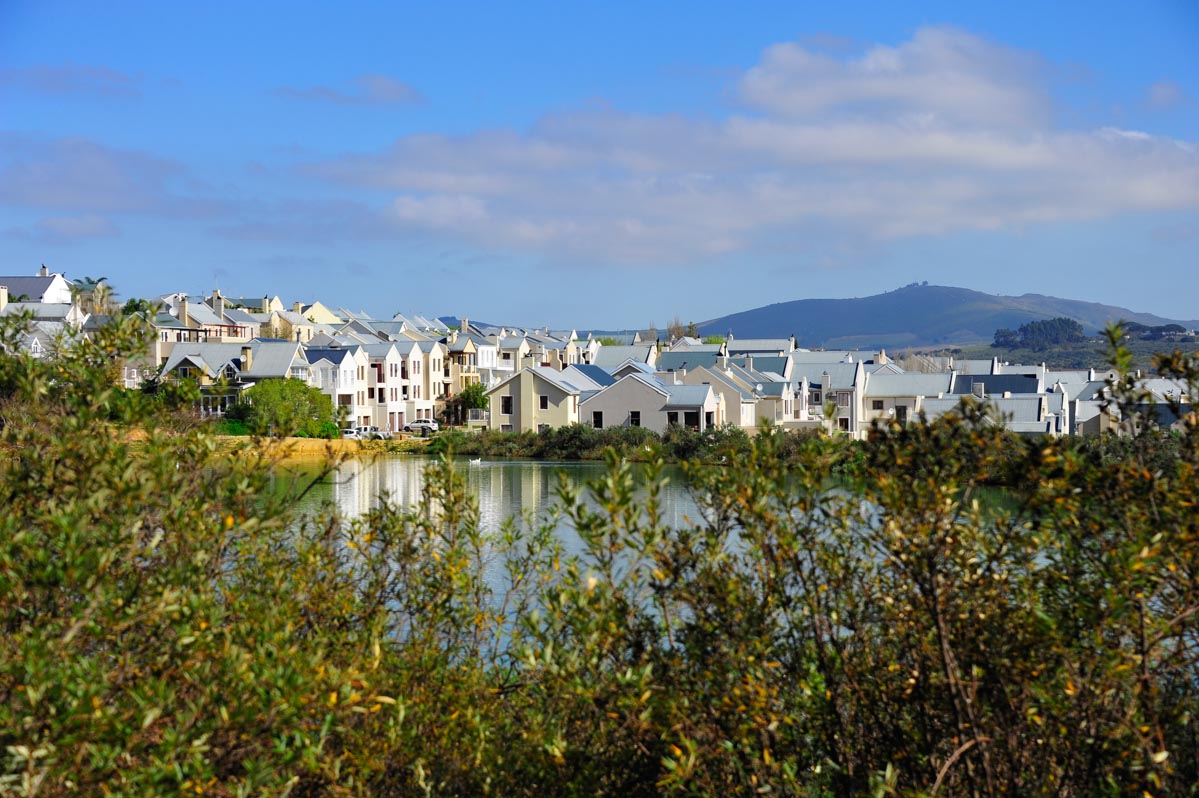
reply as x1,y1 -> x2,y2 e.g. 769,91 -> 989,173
0,267 -> 1191,437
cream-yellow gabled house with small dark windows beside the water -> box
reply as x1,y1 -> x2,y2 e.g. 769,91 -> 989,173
487,365 -> 582,433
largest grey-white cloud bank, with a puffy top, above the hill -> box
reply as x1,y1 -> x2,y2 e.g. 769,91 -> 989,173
292,28 -> 1199,264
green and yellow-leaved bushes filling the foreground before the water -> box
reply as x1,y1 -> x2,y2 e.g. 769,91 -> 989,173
0,311 -> 1199,797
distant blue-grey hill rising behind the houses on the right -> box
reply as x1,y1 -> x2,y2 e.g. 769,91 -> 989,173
699,284 -> 1199,349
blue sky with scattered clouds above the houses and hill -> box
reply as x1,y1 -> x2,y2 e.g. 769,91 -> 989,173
0,0 -> 1199,327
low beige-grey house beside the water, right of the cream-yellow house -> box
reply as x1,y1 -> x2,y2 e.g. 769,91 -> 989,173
579,373 -> 724,434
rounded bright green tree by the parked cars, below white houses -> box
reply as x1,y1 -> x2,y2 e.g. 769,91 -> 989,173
229,379 -> 338,437
